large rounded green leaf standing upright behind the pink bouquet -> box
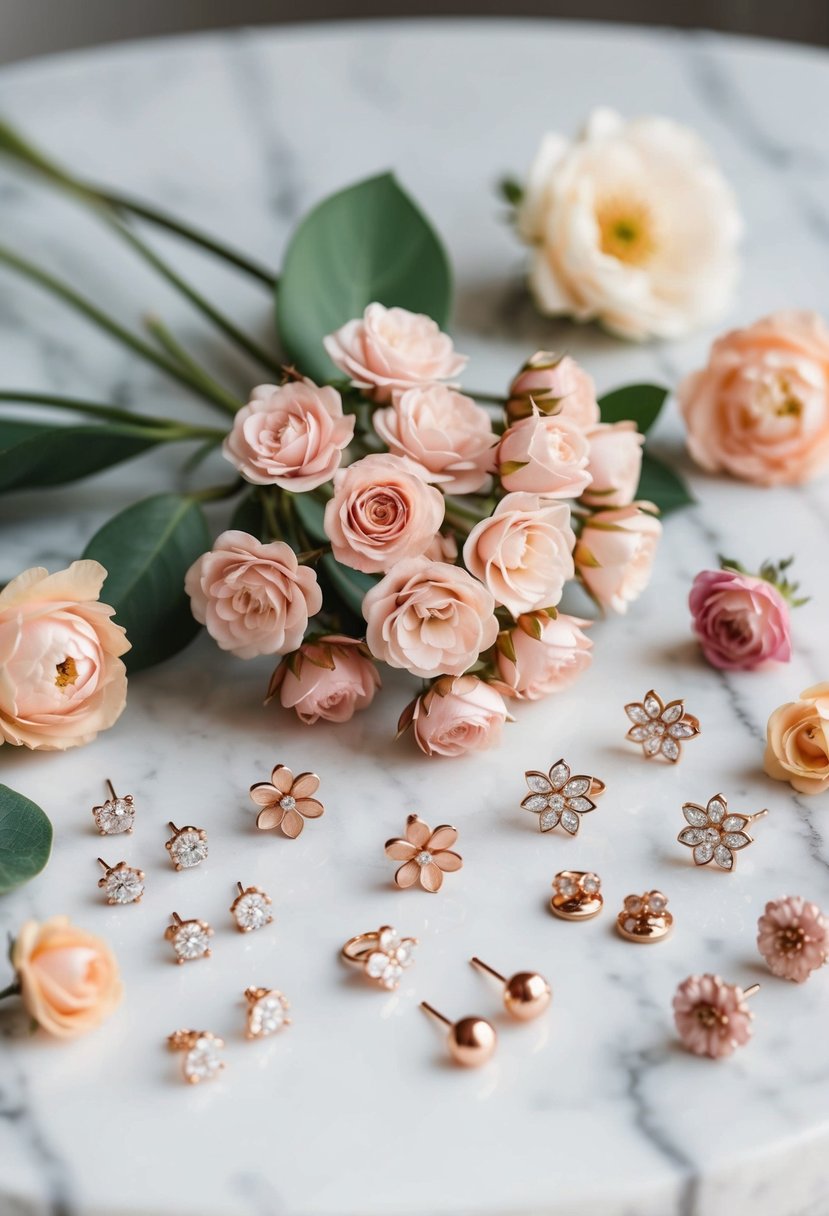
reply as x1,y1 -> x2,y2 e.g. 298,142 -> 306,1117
276,174 -> 452,382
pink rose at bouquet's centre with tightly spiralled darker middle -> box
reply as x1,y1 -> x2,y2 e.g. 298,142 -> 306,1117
325,455 -> 445,574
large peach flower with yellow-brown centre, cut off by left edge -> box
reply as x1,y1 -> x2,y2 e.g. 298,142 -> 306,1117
0,561 -> 130,751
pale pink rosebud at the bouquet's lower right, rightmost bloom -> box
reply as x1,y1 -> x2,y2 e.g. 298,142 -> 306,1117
573,503 -> 662,613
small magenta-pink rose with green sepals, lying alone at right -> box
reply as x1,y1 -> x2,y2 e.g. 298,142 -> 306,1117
688,570 -> 791,671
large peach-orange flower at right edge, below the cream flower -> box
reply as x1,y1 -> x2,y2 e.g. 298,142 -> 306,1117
678,313 -> 829,485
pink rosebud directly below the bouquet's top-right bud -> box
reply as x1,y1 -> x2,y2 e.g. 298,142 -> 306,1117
495,409 -> 590,499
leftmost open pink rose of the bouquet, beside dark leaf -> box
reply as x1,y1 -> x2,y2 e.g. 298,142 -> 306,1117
185,531 -> 322,659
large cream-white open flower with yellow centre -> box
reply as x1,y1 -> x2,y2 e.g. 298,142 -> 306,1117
518,109 -> 743,339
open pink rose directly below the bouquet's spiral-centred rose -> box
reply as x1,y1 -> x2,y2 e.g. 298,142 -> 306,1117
362,557 -> 498,679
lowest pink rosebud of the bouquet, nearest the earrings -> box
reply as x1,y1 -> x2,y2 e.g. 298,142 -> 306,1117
399,676 -> 509,756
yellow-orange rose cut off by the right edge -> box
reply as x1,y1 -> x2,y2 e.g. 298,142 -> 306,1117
763,682 -> 829,794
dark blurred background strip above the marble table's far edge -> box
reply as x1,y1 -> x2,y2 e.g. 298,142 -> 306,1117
0,0 -> 829,65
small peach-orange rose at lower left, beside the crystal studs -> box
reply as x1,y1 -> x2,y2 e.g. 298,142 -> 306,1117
11,916 -> 124,1038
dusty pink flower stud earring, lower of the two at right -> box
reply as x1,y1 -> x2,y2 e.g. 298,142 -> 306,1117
673,975 -> 760,1060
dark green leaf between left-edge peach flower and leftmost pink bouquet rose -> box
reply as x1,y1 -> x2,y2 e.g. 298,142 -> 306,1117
84,494 -> 210,671
